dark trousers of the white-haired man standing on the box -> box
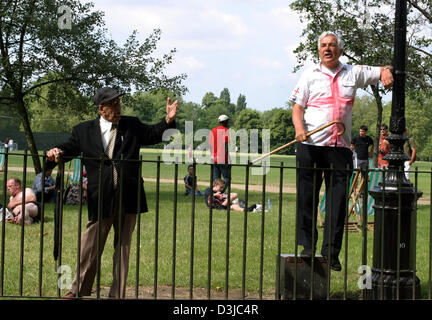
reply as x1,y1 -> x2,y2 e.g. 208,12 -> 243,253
296,143 -> 352,257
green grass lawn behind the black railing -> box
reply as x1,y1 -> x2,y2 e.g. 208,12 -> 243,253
0,151 -> 430,299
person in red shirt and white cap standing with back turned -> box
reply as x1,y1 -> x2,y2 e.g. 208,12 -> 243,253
209,114 -> 231,192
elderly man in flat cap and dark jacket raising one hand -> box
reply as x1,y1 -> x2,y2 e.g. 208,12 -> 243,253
47,88 -> 178,298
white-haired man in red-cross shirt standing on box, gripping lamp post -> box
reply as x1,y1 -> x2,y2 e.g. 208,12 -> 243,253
289,31 -> 393,271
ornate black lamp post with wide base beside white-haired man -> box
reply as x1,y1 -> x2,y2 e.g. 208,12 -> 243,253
367,0 -> 422,299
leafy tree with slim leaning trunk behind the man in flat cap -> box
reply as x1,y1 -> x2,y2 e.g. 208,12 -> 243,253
0,0 -> 186,172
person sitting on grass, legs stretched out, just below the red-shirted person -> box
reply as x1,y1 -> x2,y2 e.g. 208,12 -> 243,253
204,178 -> 261,212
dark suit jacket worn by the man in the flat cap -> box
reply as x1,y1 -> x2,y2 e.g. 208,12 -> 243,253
52,116 -> 175,221
